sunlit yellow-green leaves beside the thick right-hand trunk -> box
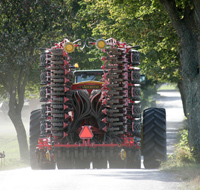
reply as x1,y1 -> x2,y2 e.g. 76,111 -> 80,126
81,0 -> 180,82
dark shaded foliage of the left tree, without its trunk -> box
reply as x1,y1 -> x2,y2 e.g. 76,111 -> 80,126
0,0 -> 74,98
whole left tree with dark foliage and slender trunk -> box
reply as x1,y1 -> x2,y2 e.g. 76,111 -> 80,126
0,0 -> 78,159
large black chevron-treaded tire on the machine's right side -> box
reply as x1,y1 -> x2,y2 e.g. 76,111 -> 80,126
142,108 -> 166,169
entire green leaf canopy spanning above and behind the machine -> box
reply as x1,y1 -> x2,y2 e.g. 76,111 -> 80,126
0,0 -> 188,97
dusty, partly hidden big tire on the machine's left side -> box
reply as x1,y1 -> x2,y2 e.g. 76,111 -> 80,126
29,109 -> 41,170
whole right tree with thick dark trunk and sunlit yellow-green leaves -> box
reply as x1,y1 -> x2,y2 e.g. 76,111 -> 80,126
79,0 -> 200,160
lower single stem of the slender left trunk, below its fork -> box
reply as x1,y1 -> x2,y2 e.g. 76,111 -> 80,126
8,108 -> 29,160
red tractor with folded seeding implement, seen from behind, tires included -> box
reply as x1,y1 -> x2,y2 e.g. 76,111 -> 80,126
30,38 -> 166,169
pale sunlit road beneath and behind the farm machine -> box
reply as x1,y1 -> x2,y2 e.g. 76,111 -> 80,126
0,91 -> 183,190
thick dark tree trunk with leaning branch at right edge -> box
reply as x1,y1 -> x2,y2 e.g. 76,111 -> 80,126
160,0 -> 200,162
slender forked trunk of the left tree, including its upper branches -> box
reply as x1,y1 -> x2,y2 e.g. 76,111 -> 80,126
8,62 -> 30,160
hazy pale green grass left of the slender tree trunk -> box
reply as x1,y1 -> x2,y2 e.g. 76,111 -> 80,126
0,136 -> 29,171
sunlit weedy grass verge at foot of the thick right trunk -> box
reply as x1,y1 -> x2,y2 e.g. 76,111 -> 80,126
160,129 -> 200,190
